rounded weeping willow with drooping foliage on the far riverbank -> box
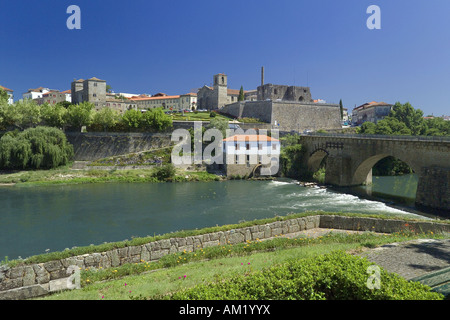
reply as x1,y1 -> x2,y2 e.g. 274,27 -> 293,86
0,127 -> 73,169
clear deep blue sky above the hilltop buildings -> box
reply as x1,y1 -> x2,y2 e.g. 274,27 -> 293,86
0,0 -> 450,115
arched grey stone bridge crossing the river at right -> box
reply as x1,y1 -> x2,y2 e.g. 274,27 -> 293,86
302,134 -> 450,211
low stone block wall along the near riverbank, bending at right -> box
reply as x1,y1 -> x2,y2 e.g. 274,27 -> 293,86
0,215 -> 450,300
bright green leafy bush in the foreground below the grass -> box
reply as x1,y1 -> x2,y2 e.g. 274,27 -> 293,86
170,251 -> 444,300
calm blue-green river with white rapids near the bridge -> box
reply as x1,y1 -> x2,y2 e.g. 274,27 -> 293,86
0,177 -> 436,260
